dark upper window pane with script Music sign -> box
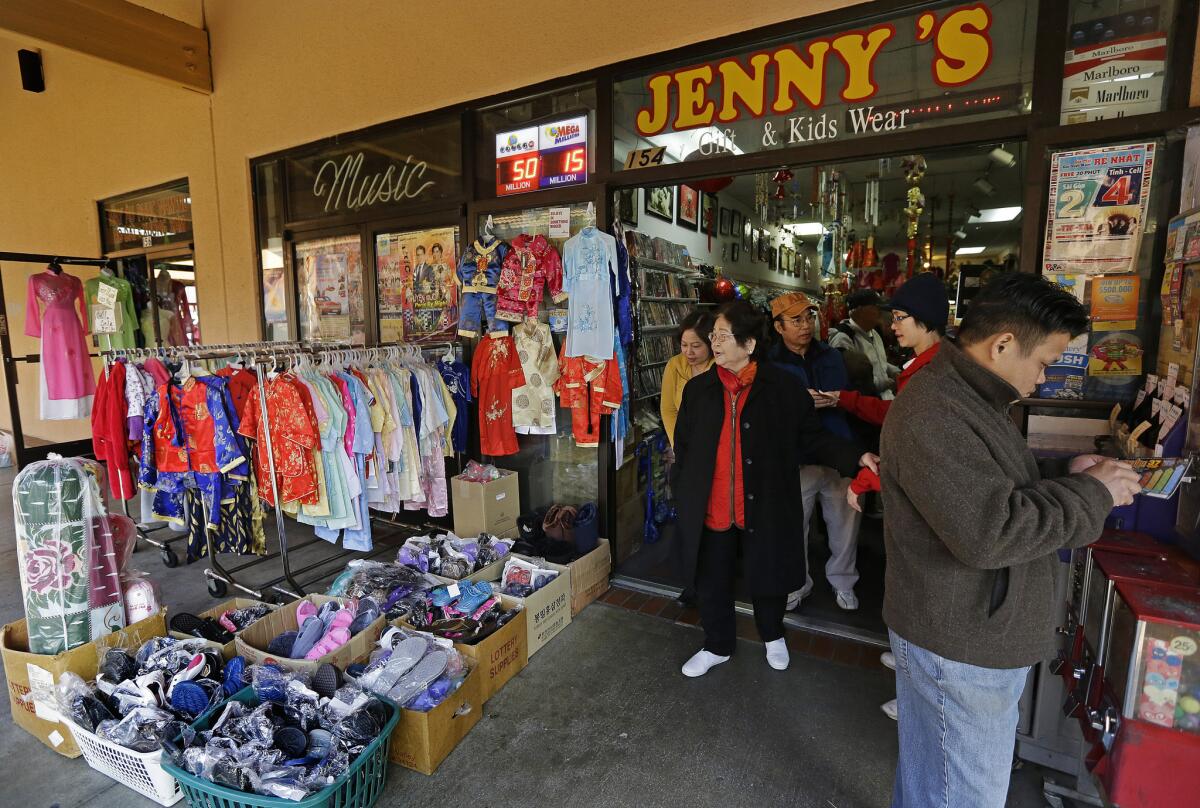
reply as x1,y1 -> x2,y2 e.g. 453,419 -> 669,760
283,115 -> 462,222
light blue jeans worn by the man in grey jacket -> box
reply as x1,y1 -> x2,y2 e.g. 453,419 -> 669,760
889,632 -> 1030,808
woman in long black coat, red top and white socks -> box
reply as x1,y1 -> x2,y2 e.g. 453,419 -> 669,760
674,300 -> 872,676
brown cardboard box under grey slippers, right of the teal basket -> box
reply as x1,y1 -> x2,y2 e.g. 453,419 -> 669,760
388,670 -> 484,774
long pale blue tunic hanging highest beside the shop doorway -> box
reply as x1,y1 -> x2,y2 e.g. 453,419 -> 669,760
563,226 -> 617,359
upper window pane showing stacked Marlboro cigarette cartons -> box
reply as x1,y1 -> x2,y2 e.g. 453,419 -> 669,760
1061,0 -> 1176,124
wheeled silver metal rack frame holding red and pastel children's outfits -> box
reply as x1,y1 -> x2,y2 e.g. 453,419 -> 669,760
110,342 -> 454,600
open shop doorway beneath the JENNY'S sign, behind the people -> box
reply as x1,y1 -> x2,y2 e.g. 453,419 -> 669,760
616,143 -> 1025,645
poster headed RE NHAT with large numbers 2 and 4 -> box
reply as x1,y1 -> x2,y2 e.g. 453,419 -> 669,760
1042,143 -> 1154,275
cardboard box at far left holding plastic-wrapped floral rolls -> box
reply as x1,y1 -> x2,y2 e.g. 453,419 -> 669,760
0,609 -> 167,758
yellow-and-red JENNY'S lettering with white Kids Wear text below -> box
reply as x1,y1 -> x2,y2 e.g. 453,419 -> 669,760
636,2 -> 992,139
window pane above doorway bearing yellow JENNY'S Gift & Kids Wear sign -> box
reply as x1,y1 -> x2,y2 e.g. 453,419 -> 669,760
612,0 -> 1038,169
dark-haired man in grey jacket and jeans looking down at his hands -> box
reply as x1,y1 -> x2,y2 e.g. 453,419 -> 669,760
880,273 -> 1140,808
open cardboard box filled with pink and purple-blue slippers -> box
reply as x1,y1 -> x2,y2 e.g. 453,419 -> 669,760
234,594 -> 385,674
